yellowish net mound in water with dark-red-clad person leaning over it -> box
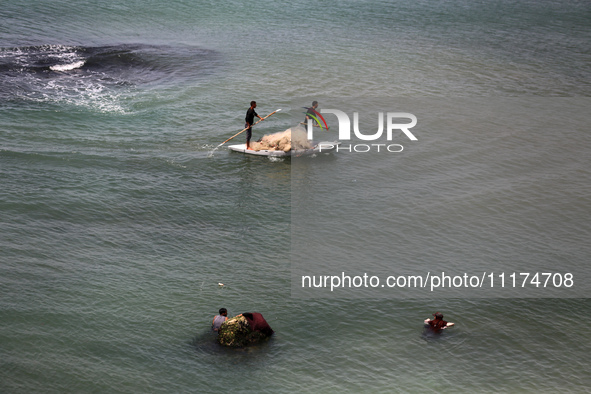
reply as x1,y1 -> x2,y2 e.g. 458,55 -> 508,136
218,312 -> 273,347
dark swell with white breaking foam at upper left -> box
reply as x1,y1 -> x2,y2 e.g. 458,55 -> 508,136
0,44 -> 219,112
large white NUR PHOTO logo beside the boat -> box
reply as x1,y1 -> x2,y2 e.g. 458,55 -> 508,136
307,109 -> 418,152
